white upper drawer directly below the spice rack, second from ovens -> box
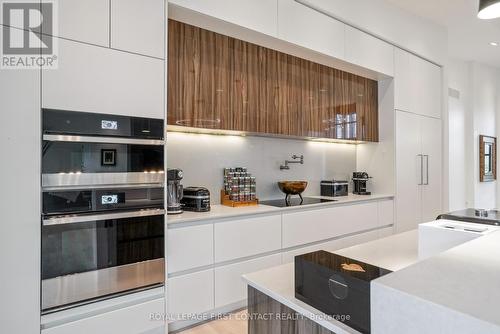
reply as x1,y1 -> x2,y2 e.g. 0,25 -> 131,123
214,214 -> 281,262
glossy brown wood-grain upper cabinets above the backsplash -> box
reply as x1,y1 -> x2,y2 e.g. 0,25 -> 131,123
167,20 -> 378,141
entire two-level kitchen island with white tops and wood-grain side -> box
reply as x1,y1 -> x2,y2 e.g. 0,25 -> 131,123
243,230 -> 500,334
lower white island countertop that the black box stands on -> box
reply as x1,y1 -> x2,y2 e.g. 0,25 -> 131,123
243,230 -> 418,334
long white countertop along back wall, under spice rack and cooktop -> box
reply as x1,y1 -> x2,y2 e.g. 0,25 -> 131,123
167,194 -> 394,224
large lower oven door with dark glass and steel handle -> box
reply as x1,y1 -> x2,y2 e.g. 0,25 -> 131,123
42,209 -> 164,313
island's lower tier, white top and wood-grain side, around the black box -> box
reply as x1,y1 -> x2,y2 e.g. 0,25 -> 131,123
243,230 -> 418,334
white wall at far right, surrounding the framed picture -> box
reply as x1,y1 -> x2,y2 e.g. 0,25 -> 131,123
448,60 -> 500,210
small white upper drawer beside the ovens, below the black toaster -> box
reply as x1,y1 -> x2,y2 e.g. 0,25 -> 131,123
167,224 -> 214,274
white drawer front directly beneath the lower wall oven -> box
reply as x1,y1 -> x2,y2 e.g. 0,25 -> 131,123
42,298 -> 165,334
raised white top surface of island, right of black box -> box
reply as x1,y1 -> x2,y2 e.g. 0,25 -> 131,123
376,231 -> 500,333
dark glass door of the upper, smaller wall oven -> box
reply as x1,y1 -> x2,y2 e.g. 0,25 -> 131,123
42,140 -> 164,187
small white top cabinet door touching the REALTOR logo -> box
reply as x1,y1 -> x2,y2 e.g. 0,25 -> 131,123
41,0 -> 109,47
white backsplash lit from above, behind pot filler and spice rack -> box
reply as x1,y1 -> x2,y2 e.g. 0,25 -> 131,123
167,132 -> 356,204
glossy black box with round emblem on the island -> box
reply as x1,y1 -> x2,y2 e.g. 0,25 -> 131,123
295,251 -> 391,333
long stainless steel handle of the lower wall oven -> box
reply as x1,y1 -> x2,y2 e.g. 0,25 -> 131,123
42,209 -> 165,226
